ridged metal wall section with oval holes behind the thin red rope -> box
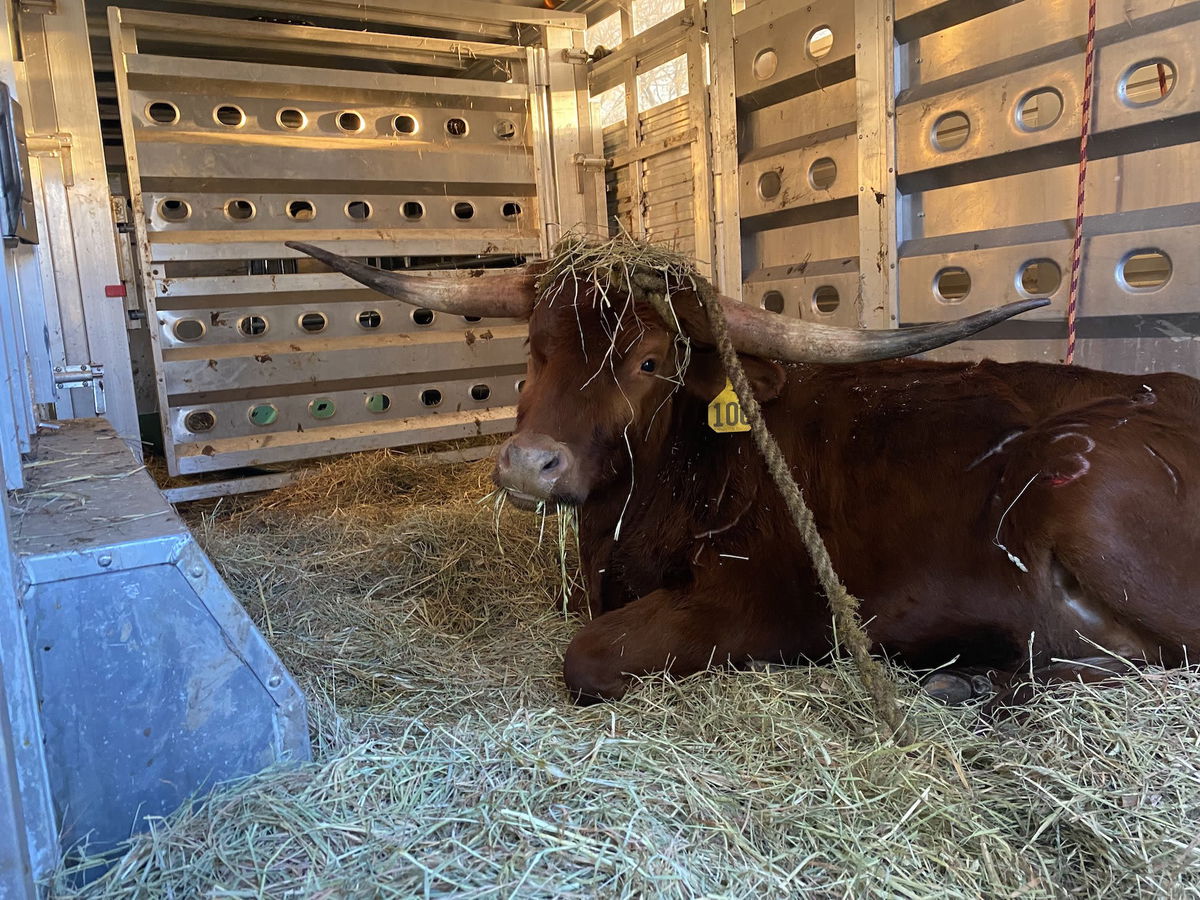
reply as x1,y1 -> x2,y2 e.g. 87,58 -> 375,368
896,0 -> 1200,373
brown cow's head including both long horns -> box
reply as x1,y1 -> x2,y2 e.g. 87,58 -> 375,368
288,242 -> 1048,506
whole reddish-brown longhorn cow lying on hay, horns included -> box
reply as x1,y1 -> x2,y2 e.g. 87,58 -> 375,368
285,245 -> 1200,700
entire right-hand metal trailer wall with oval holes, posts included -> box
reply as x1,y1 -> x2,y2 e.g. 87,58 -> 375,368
708,0 -> 1200,373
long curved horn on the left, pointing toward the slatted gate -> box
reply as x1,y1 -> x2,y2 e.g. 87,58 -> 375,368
287,241 -> 540,319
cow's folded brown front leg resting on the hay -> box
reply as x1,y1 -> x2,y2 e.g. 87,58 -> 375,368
563,590 -> 779,703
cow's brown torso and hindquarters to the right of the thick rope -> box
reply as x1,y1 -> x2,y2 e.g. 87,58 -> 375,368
768,360 -> 1200,665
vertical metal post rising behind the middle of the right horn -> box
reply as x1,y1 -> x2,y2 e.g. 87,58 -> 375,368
854,0 -> 900,328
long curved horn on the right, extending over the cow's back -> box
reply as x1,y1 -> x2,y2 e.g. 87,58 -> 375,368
721,296 -> 1050,362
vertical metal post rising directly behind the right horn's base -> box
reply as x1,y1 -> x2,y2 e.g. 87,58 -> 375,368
708,0 -> 742,300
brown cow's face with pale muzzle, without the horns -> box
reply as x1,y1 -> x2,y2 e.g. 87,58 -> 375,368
493,283 -> 784,508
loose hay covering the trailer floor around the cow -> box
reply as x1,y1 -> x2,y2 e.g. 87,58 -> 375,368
53,454 -> 1200,900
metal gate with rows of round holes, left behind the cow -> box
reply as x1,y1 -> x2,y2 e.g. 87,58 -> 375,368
109,7 -> 595,474
